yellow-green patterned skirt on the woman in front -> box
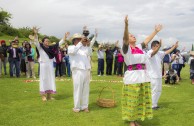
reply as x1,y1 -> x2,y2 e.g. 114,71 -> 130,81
122,83 -> 153,121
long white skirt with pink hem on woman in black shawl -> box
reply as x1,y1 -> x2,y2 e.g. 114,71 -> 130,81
40,61 -> 56,94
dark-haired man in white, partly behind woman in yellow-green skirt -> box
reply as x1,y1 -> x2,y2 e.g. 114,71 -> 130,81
147,40 -> 178,109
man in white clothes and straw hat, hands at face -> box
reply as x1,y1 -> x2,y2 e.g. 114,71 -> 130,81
68,34 -> 91,112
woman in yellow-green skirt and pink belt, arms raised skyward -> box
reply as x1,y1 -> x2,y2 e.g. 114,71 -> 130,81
122,16 -> 162,126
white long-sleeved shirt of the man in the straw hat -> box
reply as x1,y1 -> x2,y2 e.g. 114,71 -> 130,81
68,42 -> 91,70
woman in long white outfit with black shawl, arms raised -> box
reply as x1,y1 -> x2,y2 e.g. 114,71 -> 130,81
33,27 -> 69,101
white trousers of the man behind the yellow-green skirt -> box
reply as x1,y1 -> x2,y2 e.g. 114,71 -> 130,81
151,78 -> 162,107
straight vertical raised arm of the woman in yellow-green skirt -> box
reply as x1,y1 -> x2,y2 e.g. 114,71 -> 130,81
122,15 -> 129,54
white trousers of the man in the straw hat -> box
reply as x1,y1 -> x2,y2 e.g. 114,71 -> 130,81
72,69 -> 90,110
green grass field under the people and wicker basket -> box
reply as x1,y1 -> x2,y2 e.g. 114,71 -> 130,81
0,37 -> 194,126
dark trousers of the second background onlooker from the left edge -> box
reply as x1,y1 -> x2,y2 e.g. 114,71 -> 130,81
9,58 -> 20,77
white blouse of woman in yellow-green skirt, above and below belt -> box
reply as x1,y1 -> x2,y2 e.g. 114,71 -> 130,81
121,44 -> 150,85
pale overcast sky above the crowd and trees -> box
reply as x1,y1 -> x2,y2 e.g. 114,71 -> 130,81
0,0 -> 194,50
